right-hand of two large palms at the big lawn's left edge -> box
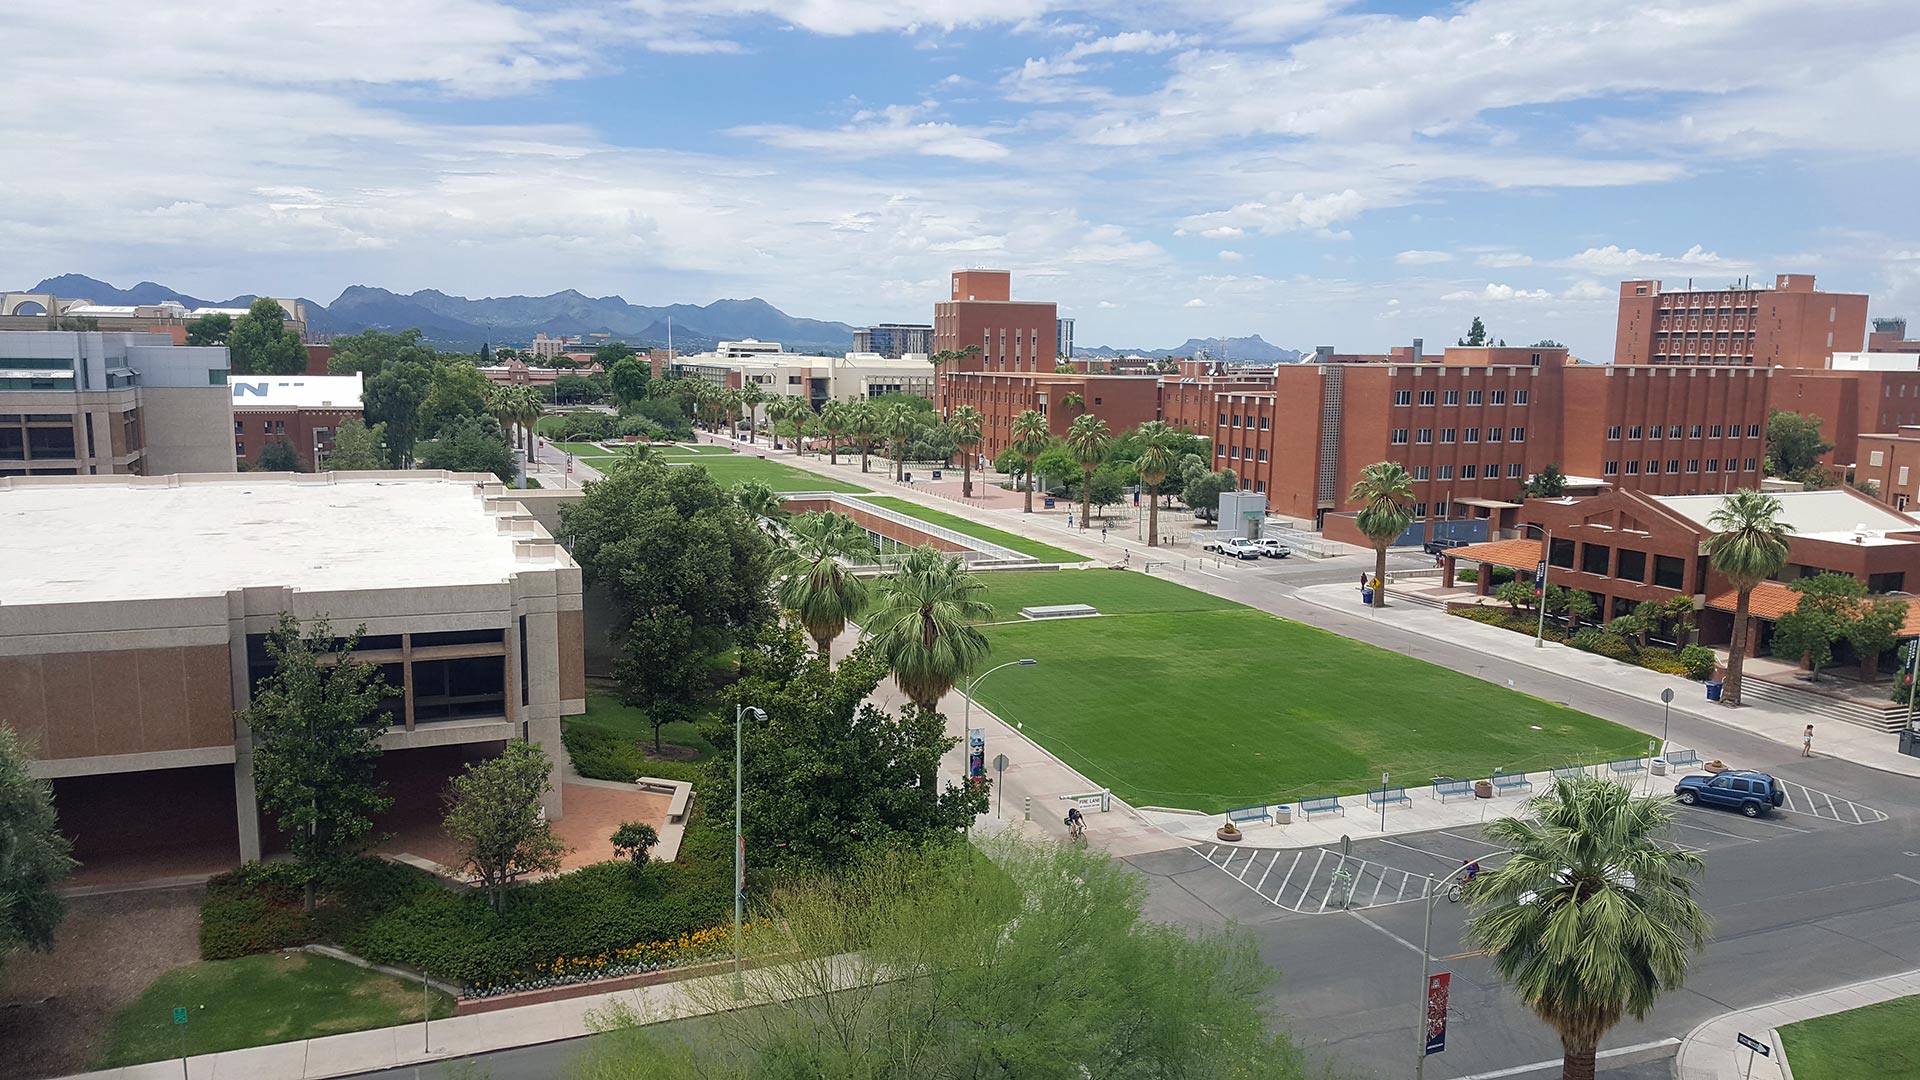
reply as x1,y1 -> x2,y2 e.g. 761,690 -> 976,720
866,548 -> 993,711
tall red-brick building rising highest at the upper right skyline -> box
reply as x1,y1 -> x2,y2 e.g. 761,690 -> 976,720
1613,273 -> 1866,367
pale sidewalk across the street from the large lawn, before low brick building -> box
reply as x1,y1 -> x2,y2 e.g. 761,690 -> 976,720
1296,584 -> 1920,776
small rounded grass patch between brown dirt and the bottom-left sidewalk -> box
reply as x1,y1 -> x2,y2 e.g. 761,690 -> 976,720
92,953 -> 453,1068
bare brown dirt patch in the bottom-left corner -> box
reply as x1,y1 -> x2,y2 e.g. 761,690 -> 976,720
0,886 -> 205,1080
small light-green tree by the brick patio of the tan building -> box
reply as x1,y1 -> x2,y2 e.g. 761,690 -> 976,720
442,738 -> 566,913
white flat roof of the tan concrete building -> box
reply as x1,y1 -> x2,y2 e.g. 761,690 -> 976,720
0,473 -> 572,611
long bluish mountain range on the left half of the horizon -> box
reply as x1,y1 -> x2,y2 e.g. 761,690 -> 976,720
23,273 -> 852,354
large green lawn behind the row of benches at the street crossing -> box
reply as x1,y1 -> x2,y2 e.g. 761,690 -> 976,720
979,571 -> 1645,811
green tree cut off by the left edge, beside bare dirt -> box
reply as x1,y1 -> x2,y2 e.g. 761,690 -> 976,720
0,724 -> 77,970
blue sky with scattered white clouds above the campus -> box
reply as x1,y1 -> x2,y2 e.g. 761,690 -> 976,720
0,0 -> 1920,359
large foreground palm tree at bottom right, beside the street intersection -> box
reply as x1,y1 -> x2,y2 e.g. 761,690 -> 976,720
1467,776 -> 1707,1080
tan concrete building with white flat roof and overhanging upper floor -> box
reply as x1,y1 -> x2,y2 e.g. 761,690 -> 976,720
0,468 -> 586,867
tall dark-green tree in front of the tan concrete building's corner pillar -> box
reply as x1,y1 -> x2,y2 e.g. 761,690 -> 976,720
238,611 -> 397,911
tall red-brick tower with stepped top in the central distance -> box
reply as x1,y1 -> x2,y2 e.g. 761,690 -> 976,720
933,269 -> 1060,407
